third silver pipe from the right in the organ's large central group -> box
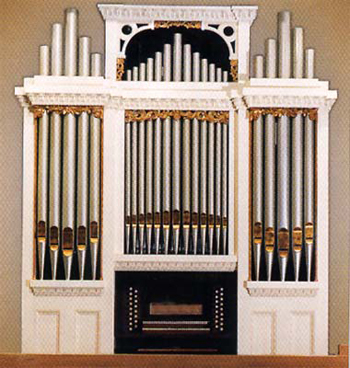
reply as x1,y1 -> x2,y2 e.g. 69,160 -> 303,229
207,123 -> 215,254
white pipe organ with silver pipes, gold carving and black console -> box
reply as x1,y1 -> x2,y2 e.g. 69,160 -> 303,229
16,4 -> 337,355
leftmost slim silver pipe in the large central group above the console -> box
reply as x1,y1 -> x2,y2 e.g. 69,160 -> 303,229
125,122 -> 133,253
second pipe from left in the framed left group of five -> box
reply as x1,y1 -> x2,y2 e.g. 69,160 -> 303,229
49,113 -> 62,280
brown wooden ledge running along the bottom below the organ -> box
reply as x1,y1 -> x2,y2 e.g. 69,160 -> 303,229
0,354 -> 348,368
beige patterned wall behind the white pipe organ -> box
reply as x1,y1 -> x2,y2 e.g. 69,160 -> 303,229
0,0 -> 350,353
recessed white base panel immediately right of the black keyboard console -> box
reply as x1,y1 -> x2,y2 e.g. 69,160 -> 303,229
251,312 -> 276,355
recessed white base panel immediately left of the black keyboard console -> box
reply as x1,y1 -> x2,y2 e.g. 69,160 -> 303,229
75,311 -> 100,354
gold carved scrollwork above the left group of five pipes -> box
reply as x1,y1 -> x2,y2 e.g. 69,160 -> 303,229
29,105 -> 103,119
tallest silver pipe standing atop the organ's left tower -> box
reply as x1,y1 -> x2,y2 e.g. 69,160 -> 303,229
64,8 -> 79,77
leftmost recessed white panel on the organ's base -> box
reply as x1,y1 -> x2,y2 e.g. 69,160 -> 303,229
35,311 -> 60,354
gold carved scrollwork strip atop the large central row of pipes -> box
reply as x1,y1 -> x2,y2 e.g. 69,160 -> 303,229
125,110 -> 229,124
